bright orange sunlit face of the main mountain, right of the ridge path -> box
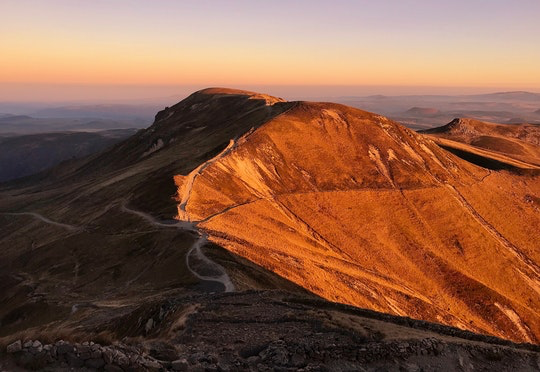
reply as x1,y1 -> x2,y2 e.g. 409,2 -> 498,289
176,99 -> 540,342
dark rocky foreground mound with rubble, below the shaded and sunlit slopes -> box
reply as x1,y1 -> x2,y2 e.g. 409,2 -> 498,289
0,291 -> 540,371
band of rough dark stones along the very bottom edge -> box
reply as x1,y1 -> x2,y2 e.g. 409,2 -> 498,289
4,338 -> 540,372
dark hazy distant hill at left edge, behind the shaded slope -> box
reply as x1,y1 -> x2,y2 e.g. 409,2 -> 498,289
0,129 -> 137,182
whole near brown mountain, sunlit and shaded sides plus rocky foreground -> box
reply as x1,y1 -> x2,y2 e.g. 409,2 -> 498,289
0,88 -> 540,371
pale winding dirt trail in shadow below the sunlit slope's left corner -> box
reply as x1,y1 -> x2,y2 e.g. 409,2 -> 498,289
122,203 -> 235,292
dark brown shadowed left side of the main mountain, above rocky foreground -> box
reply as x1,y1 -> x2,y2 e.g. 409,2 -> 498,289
0,86 -> 295,337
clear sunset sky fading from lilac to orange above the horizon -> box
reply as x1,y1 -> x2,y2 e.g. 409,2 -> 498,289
0,0 -> 540,101
